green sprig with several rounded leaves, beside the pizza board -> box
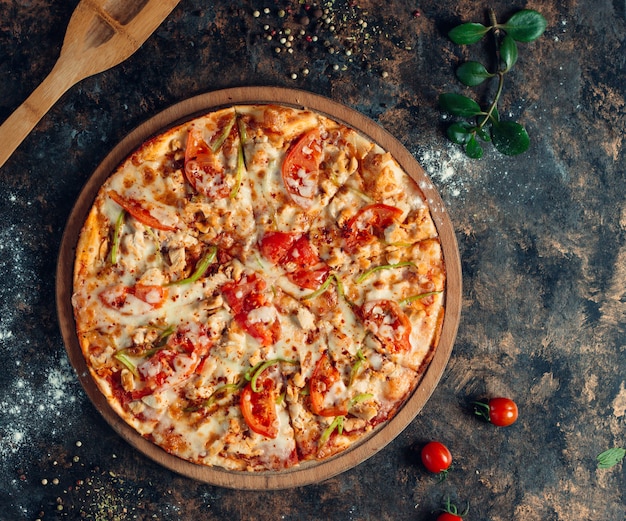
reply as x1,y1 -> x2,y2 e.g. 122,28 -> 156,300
439,9 -> 547,159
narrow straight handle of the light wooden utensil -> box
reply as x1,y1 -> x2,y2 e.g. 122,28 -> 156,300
0,60 -> 75,168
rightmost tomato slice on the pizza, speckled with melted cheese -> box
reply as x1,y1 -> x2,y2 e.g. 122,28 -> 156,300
359,299 -> 411,353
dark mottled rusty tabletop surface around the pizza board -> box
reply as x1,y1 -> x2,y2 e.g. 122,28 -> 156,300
0,0 -> 626,521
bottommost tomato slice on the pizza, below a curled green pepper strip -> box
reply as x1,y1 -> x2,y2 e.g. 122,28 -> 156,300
239,377 -> 278,439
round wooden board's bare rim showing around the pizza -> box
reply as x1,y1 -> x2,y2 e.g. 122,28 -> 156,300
56,87 -> 461,490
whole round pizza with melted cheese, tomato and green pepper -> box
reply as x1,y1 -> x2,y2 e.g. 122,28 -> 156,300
72,104 -> 446,472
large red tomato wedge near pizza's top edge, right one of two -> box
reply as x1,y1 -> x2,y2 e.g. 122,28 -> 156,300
281,128 -> 322,209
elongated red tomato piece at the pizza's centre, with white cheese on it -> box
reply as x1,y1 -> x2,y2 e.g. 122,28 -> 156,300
222,275 -> 281,346
